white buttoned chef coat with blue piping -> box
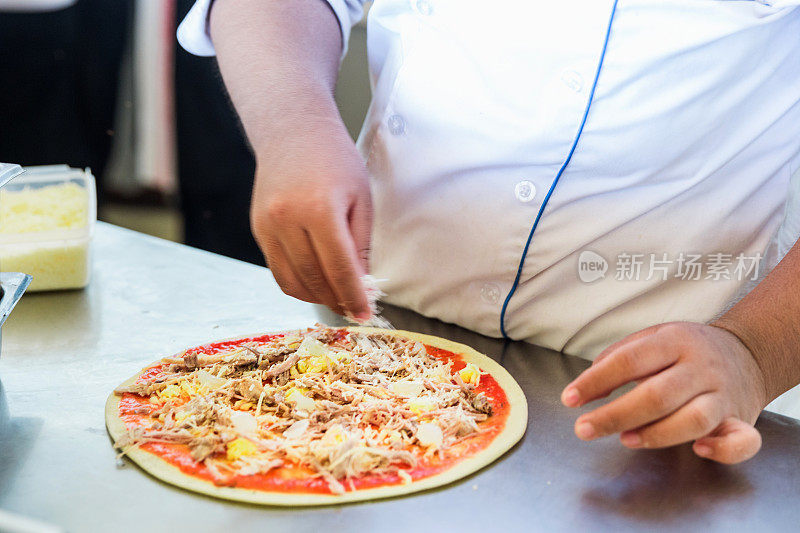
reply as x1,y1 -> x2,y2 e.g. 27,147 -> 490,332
178,0 -> 800,358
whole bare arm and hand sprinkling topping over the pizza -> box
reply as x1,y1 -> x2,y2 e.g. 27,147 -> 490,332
209,0 -> 372,318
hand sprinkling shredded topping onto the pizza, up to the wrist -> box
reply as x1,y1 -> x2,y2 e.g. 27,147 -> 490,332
250,117 -> 372,319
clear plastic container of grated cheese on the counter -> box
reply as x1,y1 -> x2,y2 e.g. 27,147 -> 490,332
0,165 -> 97,291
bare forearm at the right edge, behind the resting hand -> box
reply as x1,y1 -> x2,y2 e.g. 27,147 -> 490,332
713,239 -> 800,399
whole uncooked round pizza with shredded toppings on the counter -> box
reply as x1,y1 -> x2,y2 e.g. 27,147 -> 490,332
106,325 -> 527,505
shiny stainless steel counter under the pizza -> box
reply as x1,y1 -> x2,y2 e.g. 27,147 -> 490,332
0,224 -> 800,533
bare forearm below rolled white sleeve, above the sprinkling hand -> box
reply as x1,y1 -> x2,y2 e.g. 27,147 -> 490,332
210,0 -> 342,158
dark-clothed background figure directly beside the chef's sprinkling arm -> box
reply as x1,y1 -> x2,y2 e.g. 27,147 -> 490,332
175,0 -> 264,265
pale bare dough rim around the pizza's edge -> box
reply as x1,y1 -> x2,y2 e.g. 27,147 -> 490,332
105,327 -> 528,506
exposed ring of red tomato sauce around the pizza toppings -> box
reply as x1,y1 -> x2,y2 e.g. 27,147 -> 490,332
119,335 -> 510,494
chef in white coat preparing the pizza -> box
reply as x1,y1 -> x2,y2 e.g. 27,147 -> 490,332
178,0 -> 800,463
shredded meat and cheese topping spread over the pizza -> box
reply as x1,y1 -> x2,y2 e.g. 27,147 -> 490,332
115,325 -> 492,494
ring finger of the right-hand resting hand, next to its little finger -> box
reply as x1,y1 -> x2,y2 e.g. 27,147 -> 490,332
620,393 -> 724,448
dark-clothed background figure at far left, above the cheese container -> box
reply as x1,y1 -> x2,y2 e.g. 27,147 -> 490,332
0,0 -> 130,192
